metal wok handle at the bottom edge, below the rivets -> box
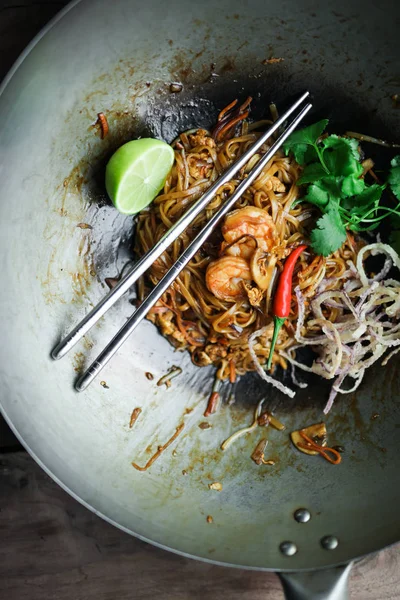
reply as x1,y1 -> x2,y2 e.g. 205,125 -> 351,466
278,563 -> 353,600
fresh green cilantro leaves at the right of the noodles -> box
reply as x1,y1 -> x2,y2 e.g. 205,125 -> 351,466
283,119 -> 400,256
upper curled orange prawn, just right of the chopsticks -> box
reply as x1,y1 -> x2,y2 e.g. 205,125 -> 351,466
221,206 -> 278,258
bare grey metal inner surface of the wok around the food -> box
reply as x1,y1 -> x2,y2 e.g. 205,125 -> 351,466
0,0 -> 400,570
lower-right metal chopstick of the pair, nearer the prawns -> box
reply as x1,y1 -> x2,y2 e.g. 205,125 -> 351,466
75,104 -> 312,392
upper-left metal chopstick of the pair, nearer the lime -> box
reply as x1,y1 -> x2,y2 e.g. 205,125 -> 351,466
51,92 -> 309,360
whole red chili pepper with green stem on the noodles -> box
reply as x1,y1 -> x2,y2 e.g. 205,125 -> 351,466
267,244 -> 307,369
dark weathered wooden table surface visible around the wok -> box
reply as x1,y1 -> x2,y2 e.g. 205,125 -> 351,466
0,0 -> 400,600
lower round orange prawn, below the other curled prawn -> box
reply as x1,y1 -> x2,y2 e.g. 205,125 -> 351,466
206,256 -> 251,302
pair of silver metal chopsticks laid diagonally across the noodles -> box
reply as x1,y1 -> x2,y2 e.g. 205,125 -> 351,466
51,92 -> 312,392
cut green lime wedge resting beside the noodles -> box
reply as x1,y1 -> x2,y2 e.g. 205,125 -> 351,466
106,138 -> 174,215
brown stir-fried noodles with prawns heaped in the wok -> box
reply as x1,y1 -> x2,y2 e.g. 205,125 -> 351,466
135,100 -> 362,390
